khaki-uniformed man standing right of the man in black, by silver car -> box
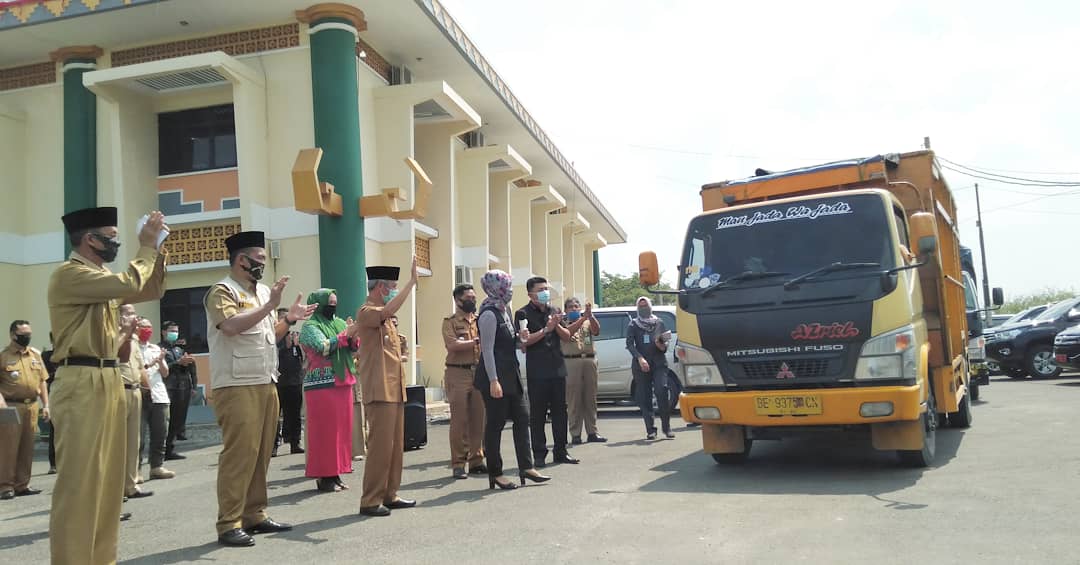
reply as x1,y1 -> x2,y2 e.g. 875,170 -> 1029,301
561,298 -> 607,445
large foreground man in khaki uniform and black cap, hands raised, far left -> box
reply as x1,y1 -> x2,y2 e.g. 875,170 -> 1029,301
49,207 -> 167,565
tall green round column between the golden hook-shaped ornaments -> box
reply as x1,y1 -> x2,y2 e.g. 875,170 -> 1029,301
310,17 -> 367,313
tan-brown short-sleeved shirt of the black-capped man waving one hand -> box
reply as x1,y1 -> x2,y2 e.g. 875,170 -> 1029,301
356,304 -> 405,404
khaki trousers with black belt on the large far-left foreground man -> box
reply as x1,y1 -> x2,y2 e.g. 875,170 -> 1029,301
49,366 -> 127,565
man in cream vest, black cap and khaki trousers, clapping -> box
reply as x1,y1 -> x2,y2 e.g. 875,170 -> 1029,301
204,231 -> 318,547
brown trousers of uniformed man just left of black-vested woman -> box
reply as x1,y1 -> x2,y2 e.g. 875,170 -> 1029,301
443,367 -> 484,469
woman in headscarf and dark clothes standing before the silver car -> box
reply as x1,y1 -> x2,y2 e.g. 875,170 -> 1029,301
626,296 -> 675,440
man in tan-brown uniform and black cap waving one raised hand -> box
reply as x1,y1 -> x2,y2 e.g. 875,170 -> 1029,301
355,258 -> 417,516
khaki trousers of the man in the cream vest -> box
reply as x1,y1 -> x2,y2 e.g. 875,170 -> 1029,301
214,382 -> 280,535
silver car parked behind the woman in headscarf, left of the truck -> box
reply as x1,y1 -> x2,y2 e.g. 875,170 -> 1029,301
594,306 -> 681,406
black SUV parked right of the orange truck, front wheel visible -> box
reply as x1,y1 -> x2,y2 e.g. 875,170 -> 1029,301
983,297 -> 1080,378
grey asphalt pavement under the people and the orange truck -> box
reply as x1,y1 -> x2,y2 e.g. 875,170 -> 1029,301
0,376 -> 1080,565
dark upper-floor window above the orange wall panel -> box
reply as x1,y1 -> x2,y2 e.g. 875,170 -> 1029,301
158,104 -> 237,175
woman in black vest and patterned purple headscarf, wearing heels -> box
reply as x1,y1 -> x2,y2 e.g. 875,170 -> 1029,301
474,270 -> 551,490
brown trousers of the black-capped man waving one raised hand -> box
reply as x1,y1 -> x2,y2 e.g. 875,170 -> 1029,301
360,402 -> 405,508
